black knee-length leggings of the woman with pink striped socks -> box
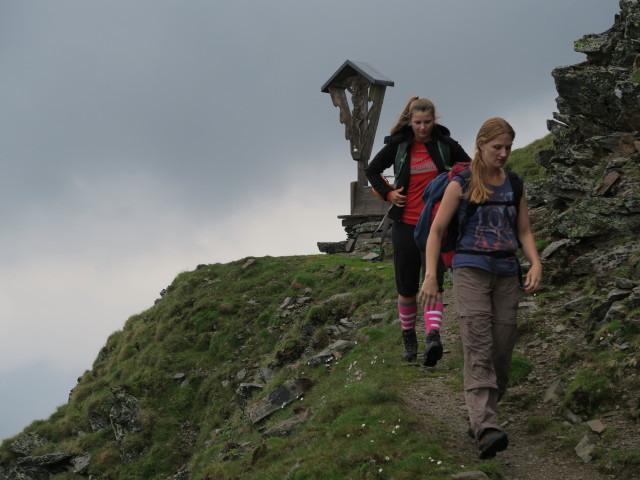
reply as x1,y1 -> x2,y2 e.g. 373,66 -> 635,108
391,221 -> 444,297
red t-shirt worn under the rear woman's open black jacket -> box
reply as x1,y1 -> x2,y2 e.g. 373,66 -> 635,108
400,142 -> 439,225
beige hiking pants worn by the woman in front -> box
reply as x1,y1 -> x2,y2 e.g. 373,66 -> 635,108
453,267 -> 519,438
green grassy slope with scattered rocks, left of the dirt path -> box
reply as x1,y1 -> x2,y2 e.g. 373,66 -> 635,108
2,255 -> 496,480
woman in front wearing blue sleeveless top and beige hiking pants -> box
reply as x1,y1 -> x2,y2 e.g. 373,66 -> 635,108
418,118 -> 542,459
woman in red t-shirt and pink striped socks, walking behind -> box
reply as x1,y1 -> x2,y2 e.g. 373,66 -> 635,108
365,96 -> 471,366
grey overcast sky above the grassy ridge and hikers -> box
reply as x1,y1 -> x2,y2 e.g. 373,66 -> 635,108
0,0 -> 619,439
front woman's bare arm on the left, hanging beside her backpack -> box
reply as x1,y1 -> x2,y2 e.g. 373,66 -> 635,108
418,182 -> 462,305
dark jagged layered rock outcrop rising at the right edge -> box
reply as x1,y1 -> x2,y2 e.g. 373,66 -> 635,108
530,0 -> 640,288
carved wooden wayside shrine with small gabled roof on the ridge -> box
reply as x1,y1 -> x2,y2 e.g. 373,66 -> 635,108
322,60 -> 394,218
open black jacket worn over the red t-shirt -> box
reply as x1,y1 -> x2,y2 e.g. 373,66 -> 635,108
365,124 -> 471,220
